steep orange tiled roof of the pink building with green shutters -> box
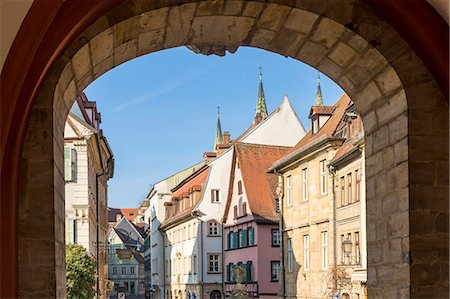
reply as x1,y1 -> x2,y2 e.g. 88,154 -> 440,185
236,142 -> 292,221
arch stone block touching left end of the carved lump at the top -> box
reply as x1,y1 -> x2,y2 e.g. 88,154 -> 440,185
164,3 -> 197,48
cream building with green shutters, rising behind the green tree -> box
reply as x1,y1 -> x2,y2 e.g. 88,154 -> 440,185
64,94 -> 114,298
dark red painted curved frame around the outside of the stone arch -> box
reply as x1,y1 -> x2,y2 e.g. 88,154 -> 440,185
0,0 -> 449,298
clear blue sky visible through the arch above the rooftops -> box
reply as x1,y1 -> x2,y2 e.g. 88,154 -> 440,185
85,47 -> 344,207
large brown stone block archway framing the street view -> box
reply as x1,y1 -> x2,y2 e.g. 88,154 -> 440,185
1,0 -> 448,297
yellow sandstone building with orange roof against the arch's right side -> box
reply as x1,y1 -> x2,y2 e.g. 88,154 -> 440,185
269,80 -> 366,298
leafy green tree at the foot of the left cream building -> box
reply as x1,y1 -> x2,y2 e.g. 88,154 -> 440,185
66,244 -> 97,298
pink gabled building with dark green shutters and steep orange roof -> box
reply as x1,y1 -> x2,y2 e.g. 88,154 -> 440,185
223,143 -> 290,298
